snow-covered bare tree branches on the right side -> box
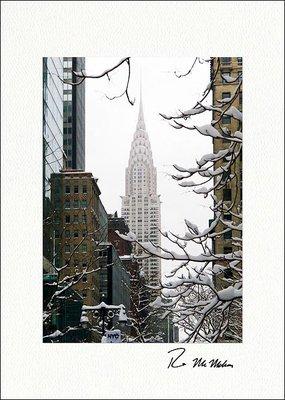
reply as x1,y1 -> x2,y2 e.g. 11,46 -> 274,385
117,58 -> 242,343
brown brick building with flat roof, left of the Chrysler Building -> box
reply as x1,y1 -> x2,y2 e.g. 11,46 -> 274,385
51,170 -> 102,305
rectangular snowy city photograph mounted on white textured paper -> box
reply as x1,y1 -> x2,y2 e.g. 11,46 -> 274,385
42,57 -> 242,344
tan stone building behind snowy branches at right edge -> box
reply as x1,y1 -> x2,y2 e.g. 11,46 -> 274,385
211,57 -> 243,342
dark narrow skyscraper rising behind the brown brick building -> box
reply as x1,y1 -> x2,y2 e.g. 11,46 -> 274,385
63,57 -> 85,170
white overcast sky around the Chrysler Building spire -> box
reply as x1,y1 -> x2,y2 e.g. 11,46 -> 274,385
86,57 -> 212,278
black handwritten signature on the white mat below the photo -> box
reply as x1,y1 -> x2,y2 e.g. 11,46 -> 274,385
167,347 -> 234,368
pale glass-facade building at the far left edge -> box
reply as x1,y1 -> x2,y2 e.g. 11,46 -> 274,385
43,57 -> 65,260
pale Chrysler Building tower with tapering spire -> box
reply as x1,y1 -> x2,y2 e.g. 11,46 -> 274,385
122,93 -> 161,285
